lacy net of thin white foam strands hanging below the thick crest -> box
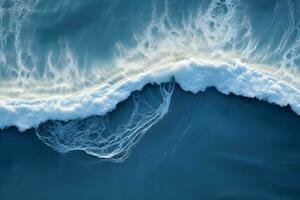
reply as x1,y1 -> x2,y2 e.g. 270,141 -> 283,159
36,81 -> 174,162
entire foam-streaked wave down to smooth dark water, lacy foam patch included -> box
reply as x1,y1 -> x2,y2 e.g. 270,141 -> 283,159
0,0 -> 300,161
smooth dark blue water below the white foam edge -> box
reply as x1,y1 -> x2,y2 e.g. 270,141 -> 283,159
0,86 -> 300,200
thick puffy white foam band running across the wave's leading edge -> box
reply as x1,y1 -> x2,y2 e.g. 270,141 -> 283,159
0,59 -> 300,131
